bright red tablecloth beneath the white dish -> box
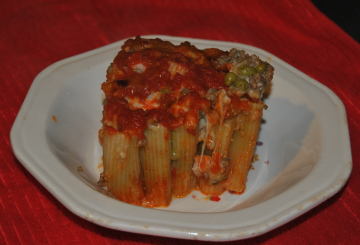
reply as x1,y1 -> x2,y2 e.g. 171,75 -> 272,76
0,0 -> 360,244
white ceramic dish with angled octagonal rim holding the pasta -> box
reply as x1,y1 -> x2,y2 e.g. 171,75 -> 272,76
11,36 -> 352,241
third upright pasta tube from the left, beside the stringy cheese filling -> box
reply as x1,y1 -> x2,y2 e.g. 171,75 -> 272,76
171,126 -> 198,197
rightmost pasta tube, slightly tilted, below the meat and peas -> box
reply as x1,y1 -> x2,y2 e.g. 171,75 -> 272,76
224,102 -> 265,194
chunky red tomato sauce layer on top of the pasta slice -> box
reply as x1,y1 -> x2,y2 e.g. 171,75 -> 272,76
101,37 -> 227,139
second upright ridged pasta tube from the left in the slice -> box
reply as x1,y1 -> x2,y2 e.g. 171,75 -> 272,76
141,124 -> 171,207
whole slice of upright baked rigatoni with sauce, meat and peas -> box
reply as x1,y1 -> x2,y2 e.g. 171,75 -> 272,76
99,36 -> 274,207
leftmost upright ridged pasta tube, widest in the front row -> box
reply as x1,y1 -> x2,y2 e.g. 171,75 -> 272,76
103,129 -> 144,205
